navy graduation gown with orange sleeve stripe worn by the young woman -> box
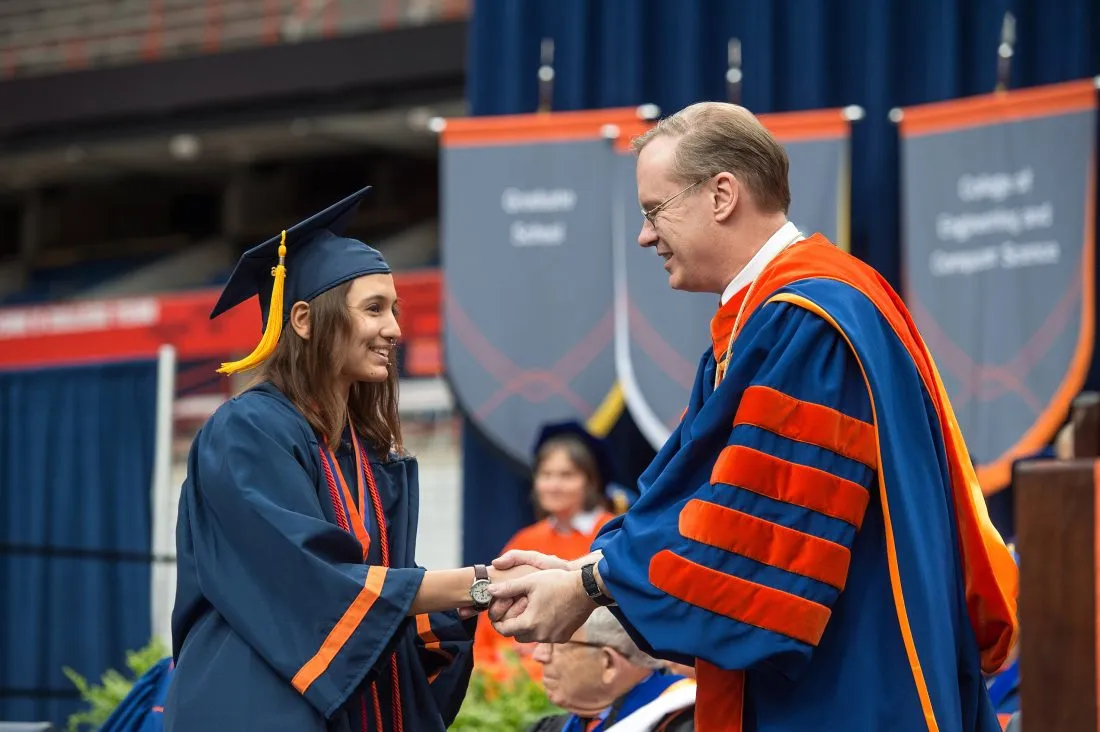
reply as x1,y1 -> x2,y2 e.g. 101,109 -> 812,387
165,384 -> 473,732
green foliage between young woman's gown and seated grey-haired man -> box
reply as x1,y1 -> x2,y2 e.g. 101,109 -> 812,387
448,658 -> 562,732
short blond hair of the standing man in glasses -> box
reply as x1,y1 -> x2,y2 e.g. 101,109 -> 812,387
634,101 -> 791,214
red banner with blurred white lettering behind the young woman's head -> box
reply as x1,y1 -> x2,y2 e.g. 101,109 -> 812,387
0,270 -> 440,376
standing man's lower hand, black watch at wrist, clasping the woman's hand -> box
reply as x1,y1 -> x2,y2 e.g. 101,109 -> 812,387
490,569 -> 596,643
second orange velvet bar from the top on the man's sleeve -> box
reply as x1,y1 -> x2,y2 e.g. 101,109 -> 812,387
711,445 -> 870,528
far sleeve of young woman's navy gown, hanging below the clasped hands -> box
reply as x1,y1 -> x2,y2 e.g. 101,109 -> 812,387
416,612 -> 477,725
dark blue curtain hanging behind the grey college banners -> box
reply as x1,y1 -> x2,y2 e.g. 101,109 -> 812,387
464,0 -> 1100,560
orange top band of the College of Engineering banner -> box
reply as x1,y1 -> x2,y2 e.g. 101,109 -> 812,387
899,79 -> 1097,136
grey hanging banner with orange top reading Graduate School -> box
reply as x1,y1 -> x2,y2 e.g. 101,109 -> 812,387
440,108 -> 641,465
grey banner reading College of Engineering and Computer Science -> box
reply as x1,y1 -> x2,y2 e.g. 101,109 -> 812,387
900,80 -> 1097,494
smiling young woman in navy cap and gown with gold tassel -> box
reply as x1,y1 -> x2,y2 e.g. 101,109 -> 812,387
165,189 -> 521,732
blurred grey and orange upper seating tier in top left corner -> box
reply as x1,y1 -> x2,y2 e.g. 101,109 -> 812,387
0,0 -> 471,78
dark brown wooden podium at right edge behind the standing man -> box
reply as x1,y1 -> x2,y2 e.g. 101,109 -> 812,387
1013,393 -> 1100,732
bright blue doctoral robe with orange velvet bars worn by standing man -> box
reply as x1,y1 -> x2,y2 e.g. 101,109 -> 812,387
593,237 -> 1015,732
